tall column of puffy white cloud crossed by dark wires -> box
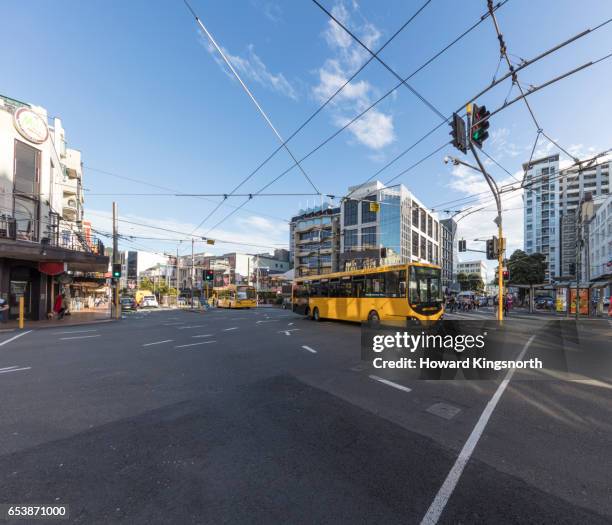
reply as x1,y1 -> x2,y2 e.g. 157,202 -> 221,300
312,2 -> 395,151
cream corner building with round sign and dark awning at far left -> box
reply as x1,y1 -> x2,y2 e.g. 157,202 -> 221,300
0,96 -> 108,320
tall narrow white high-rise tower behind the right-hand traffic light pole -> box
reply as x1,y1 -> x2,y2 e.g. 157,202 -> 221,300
523,155 -> 561,281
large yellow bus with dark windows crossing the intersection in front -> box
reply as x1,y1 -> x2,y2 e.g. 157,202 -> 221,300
292,263 -> 444,322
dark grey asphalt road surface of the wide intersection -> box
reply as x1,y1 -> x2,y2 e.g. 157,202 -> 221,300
0,308 -> 612,524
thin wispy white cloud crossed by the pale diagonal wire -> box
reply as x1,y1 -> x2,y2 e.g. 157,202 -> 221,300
202,39 -> 299,100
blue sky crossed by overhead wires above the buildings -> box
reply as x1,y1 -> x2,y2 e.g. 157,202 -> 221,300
0,0 -> 612,260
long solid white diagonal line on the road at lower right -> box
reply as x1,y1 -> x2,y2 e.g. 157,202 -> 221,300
421,334 -> 535,525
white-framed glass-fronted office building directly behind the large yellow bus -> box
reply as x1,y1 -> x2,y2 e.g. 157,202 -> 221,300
340,181 -> 440,270
